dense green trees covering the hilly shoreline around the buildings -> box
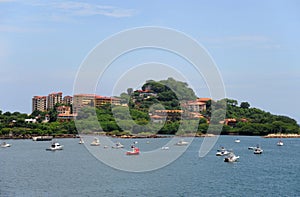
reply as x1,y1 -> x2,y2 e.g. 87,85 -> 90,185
0,78 -> 300,137
